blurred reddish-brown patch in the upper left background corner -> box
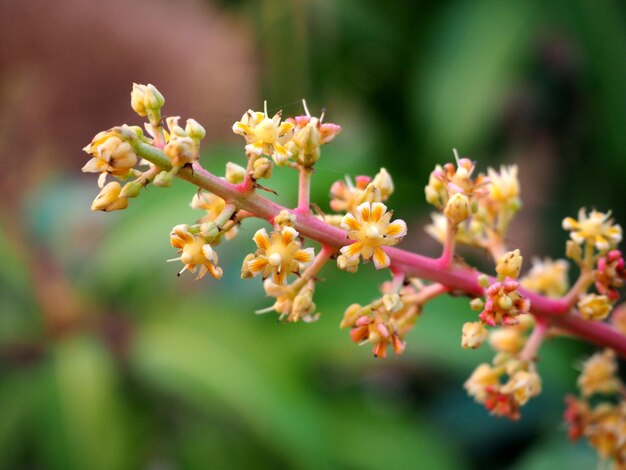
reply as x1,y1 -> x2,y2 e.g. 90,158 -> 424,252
0,0 -> 257,206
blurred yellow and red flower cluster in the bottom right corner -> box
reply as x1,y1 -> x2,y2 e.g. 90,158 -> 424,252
564,349 -> 626,468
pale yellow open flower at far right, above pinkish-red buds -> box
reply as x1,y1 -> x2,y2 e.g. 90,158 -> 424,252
563,208 -> 622,251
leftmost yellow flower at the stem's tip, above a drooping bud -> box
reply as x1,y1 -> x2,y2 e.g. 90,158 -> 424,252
82,131 -> 138,188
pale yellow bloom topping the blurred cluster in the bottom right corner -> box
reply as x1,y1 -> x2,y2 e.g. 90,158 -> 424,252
578,349 -> 621,397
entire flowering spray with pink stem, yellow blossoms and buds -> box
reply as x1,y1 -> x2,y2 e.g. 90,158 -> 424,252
83,84 -> 626,466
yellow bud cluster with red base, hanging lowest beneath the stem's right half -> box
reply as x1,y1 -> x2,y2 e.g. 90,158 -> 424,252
464,353 -> 541,420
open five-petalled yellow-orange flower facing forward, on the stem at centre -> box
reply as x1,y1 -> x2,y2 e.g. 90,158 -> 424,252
341,202 -> 406,269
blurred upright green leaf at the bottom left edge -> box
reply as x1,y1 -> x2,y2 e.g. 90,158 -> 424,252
40,336 -> 133,470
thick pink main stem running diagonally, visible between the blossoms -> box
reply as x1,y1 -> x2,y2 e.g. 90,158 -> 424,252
133,141 -> 626,357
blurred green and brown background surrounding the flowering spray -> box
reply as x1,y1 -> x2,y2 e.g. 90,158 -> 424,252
0,0 -> 626,469
